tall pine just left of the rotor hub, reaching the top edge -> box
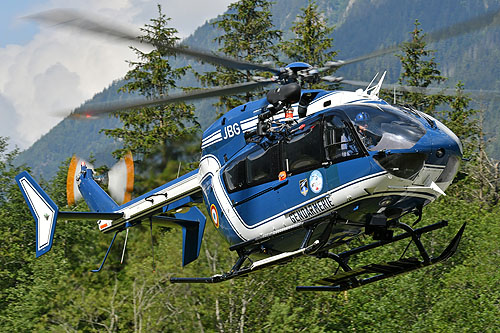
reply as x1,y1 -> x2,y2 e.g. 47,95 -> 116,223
198,0 -> 281,113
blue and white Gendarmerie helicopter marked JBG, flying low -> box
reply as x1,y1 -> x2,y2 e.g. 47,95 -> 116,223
16,9 -> 499,291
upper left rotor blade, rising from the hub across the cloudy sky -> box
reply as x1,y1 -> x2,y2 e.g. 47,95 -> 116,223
25,9 -> 280,74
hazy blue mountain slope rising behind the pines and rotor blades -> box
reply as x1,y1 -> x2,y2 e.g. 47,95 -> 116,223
14,0 -> 500,177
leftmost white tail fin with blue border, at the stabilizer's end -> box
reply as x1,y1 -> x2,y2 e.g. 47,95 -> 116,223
16,171 -> 59,258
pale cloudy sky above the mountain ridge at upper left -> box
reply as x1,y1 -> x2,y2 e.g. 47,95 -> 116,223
0,0 -> 235,149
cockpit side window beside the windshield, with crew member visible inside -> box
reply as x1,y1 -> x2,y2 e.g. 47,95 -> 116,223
323,115 -> 362,163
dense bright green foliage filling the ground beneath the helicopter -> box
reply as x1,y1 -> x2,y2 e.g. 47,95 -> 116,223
0,1 -> 500,332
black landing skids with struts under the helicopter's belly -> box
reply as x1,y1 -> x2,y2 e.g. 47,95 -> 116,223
170,215 -> 466,291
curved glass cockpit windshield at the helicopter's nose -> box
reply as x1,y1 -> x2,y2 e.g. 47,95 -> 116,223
344,104 -> 425,151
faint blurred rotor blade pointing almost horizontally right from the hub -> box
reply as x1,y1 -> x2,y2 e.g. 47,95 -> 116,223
342,80 -> 500,99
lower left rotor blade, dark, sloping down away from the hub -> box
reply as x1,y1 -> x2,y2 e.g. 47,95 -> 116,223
71,79 -> 275,118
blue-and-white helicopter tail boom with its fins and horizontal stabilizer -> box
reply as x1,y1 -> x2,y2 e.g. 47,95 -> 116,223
16,166 -> 206,266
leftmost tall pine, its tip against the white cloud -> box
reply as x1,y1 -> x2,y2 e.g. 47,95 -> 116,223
104,5 -> 199,161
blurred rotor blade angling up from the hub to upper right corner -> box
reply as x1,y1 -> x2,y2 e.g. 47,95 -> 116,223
319,9 -> 500,72
